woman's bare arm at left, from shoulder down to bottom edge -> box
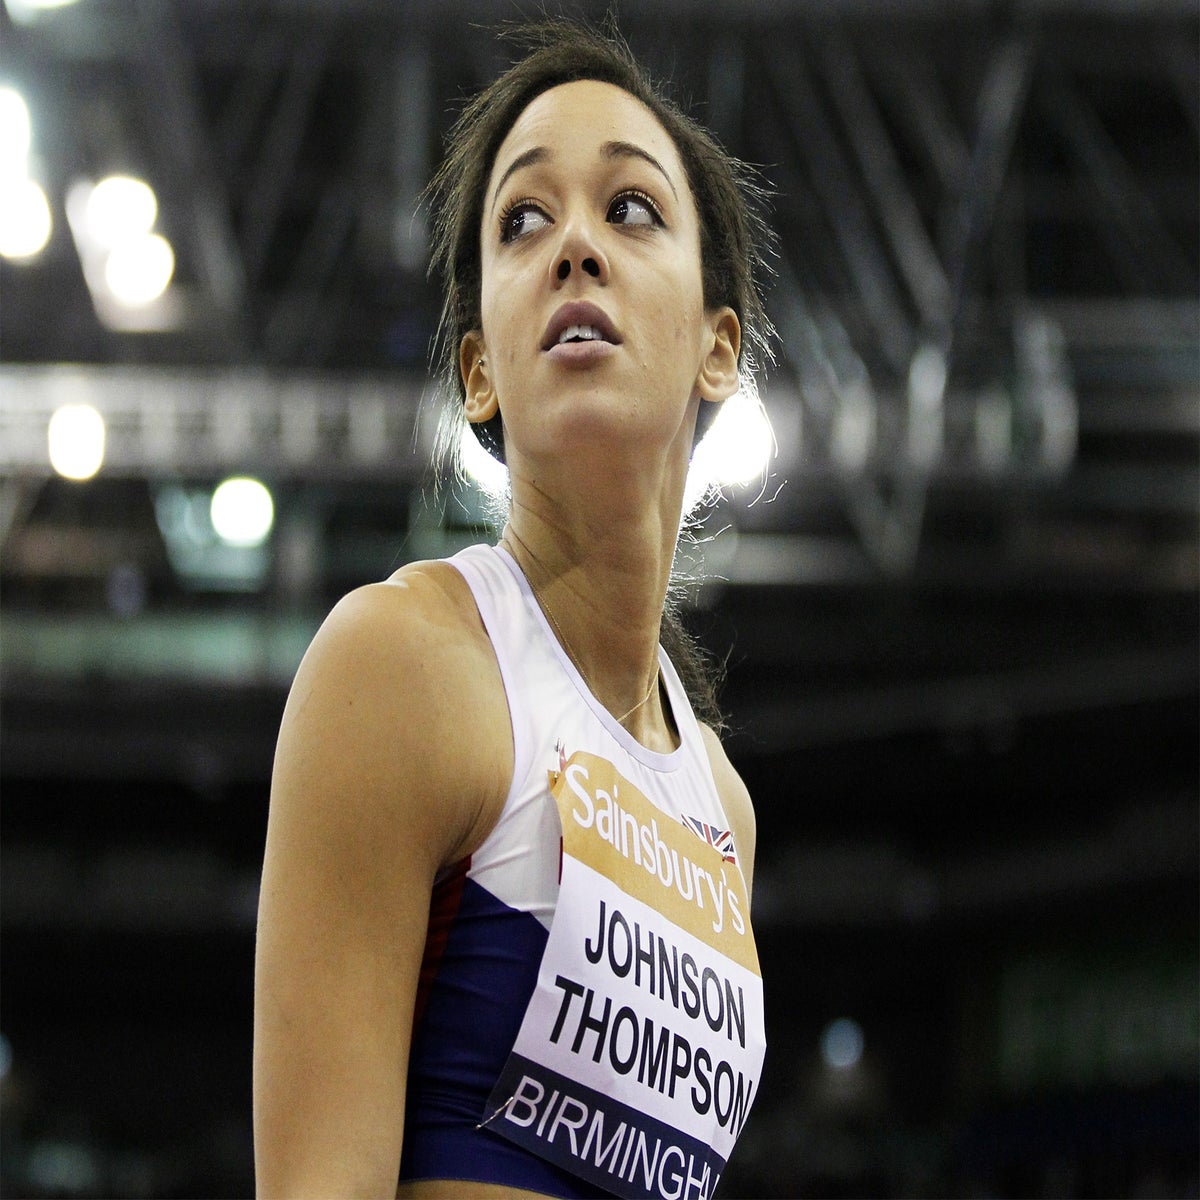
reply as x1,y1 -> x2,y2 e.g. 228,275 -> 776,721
254,568 -> 511,1196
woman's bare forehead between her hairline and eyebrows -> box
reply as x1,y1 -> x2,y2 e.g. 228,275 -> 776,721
488,79 -> 686,194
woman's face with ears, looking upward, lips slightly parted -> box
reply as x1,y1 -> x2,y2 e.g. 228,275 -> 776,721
461,80 -> 738,472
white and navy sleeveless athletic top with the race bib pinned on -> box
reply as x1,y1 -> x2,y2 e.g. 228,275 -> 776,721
401,546 -> 764,1200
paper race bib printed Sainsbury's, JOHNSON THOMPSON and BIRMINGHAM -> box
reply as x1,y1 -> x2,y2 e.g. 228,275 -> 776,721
484,752 -> 766,1200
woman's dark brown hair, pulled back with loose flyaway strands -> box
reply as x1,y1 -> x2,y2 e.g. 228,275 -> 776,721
427,18 -> 772,726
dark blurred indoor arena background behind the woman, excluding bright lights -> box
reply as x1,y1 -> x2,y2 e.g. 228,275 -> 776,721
0,0 -> 1200,1196
